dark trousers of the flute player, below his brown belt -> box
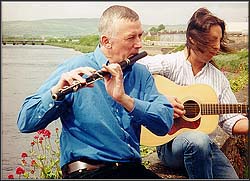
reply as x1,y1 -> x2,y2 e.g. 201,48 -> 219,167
64,163 -> 162,179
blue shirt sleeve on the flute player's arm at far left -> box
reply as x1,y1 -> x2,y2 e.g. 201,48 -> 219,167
17,61 -> 70,133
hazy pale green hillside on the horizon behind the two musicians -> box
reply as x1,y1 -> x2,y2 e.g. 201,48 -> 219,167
2,18 -> 185,38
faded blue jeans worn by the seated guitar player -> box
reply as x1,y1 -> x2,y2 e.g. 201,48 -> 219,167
157,131 -> 239,179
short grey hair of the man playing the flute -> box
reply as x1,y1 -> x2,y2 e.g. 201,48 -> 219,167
98,5 -> 139,37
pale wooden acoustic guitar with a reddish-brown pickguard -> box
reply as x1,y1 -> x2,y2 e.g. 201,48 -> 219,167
140,75 -> 249,146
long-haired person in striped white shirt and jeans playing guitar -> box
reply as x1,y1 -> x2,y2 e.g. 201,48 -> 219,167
139,8 -> 248,179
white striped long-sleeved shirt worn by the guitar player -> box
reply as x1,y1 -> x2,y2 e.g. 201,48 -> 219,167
137,51 -> 244,136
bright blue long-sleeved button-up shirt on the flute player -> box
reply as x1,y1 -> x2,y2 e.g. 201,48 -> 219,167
17,47 -> 173,166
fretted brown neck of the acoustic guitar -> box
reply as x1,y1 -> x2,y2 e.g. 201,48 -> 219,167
201,104 -> 249,115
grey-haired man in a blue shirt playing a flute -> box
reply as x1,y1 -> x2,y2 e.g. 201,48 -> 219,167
17,5 -> 173,179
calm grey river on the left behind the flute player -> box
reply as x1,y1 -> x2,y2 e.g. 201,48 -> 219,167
1,45 -> 81,179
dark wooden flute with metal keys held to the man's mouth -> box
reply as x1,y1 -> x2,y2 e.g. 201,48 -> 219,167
52,51 -> 147,100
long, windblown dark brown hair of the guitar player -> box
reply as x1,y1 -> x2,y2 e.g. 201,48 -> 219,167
186,8 -> 232,65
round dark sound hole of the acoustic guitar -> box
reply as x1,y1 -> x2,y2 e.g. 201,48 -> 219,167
184,100 -> 200,118
